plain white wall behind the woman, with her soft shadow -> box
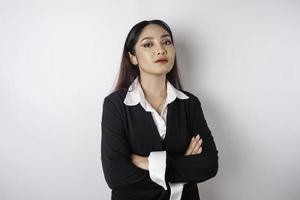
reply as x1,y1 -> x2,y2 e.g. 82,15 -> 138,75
0,0 -> 300,200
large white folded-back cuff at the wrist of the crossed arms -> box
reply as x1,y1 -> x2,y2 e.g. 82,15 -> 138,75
148,151 -> 168,190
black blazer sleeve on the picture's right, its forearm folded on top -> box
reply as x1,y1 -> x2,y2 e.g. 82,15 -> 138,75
165,96 -> 218,183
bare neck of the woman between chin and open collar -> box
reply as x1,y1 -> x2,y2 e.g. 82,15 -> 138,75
139,74 -> 167,98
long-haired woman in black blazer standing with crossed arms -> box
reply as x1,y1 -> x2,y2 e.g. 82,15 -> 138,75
101,20 -> 218,200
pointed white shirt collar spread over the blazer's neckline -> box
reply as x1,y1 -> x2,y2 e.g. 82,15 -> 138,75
124,76 -> 189,111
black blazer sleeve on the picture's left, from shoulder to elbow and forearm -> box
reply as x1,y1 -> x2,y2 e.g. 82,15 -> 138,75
101,97 -> 155,189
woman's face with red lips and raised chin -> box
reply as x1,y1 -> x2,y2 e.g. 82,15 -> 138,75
128,24 -> 175,75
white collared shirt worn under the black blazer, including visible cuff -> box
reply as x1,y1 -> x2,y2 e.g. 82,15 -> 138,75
124,76 -> 189,200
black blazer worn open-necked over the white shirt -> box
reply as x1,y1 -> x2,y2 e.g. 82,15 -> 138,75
101,89 -> 218,200
